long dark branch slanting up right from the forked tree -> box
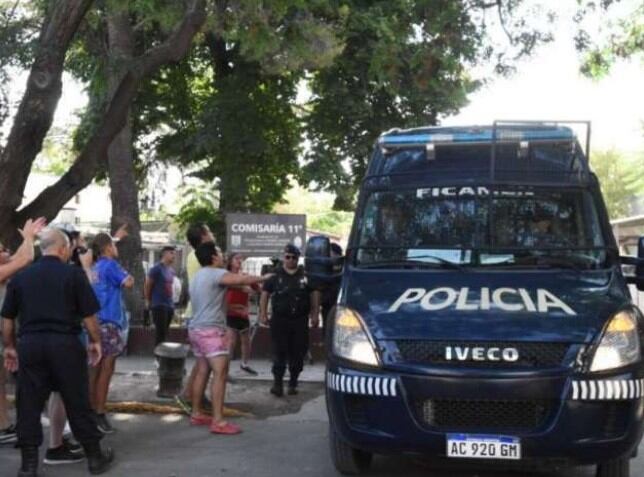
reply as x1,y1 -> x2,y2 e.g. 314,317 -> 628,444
18,0 -> 206,220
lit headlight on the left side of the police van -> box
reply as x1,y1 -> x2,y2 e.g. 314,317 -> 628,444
333,306 -> 380,366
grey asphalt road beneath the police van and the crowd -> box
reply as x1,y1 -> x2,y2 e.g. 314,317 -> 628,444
0,397 -> 644,477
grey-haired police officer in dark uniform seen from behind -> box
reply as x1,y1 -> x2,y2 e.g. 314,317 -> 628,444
0,229 -> 114,477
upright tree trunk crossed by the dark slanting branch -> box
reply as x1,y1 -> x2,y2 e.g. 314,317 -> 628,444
107,6 -> 145,323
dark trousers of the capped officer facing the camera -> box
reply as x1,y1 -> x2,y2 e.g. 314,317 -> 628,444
271,316 -> 309,386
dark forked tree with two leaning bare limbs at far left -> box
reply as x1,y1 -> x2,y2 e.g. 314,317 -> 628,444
0,0 -> 206,247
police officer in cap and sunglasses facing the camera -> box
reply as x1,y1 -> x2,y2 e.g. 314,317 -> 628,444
259,244 -> 320,397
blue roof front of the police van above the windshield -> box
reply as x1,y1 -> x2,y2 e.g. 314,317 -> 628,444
365,121 -> 590,185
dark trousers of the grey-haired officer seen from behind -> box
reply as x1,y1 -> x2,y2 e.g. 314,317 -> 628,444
16,333 -> 102,447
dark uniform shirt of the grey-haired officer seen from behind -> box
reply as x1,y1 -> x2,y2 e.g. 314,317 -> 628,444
0,256 -> 100,336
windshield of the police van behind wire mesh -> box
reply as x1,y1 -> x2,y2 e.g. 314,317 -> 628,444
356,187 -> 606,269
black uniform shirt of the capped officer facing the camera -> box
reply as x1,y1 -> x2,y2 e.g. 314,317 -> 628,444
263,267 -> 313,319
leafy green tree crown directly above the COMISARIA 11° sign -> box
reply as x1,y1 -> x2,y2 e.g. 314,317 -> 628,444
147,1 -> 342,240
